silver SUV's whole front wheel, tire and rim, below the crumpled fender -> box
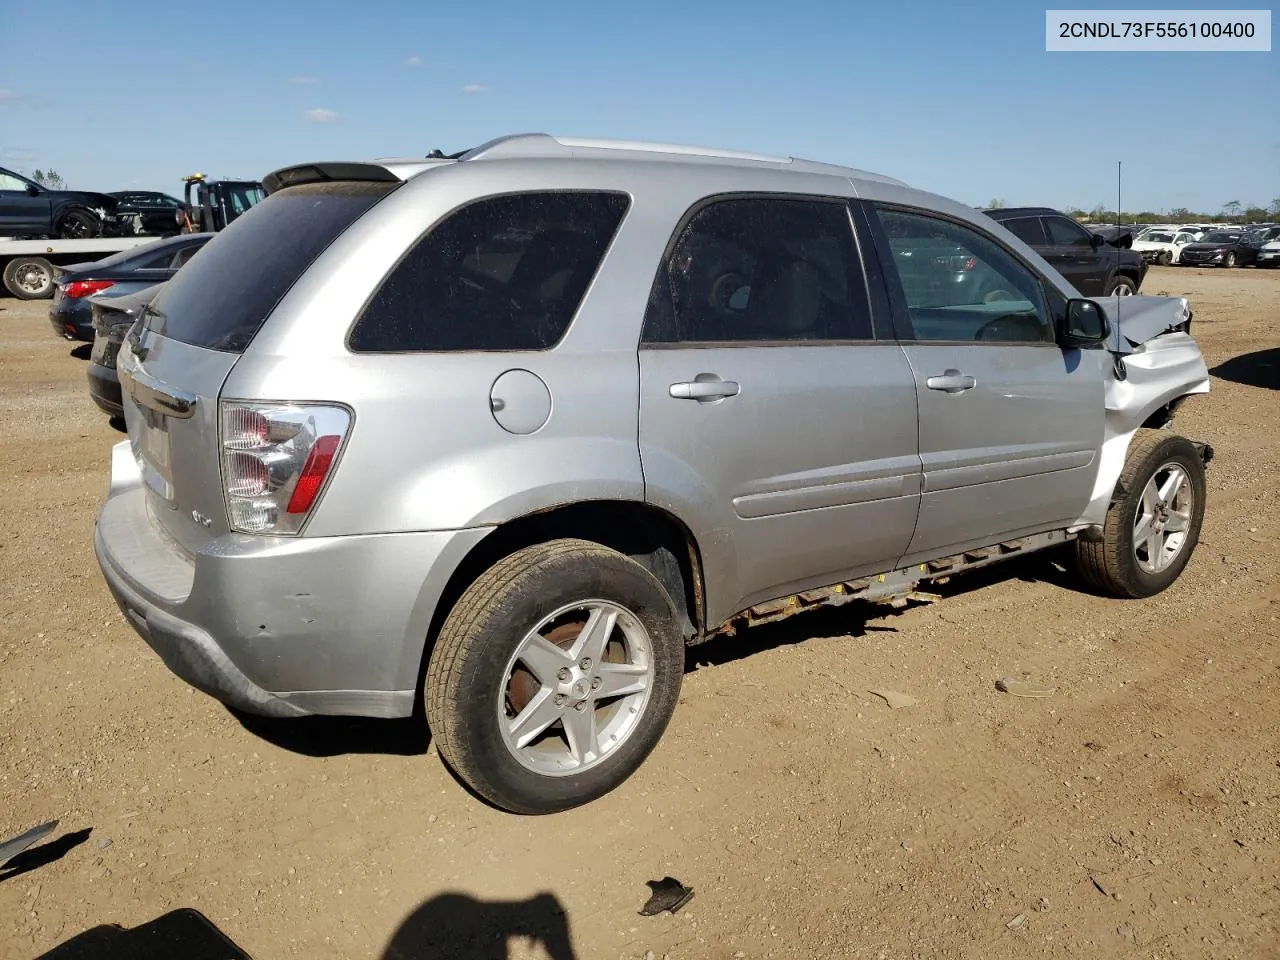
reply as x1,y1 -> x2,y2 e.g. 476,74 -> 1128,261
1075,430 -> 1204,598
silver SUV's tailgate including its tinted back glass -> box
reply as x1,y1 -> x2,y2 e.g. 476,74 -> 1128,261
118,183 -> 389,553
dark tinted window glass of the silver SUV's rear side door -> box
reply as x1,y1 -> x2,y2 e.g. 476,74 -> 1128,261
644,197 -> 872,343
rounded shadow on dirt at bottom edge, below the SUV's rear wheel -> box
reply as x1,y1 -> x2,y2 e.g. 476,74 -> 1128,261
381,893 -> 577,960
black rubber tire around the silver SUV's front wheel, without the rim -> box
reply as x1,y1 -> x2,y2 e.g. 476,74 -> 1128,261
1075,429 -> 1204,599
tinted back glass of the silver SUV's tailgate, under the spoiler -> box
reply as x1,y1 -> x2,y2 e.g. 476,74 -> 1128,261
145,183 -> 397,353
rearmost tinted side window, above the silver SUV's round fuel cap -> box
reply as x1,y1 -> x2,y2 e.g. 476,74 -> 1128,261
349,192 -> 630,353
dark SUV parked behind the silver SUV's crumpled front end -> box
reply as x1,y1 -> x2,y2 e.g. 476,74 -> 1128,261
983,206 -> 1147,297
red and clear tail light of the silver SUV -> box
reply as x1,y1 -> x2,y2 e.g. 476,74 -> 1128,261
220,401 -> 351,536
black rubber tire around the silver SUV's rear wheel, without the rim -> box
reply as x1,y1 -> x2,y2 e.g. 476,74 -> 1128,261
424,540 -> 685,814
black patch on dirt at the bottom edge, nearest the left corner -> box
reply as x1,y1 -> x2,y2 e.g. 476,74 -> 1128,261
36,908 -> 252,960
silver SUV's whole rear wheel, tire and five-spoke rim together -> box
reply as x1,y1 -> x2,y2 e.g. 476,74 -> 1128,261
424,540 -> 685,814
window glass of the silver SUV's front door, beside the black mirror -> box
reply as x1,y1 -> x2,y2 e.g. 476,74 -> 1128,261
876,207 -> 1055,343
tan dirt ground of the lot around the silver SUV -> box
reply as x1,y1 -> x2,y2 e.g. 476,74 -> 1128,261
0,268 -> 1280,960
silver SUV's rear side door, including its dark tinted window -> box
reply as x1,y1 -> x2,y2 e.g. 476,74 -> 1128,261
640,196 -> 920,623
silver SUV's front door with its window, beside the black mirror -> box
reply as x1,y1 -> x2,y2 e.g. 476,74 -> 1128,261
864,204 -> 1105,564
